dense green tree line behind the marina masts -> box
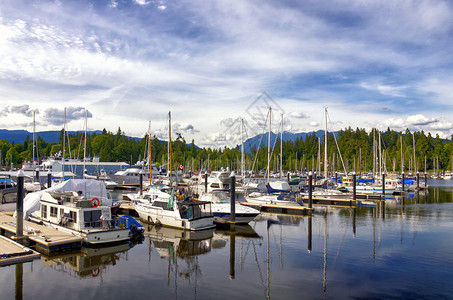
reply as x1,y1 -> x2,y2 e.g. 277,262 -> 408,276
0,127 -> 453,173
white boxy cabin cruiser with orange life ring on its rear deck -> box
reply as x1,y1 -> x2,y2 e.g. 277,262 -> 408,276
29,191 -> 137,245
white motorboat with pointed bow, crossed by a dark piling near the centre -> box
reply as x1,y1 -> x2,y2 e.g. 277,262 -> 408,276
199,190 -> 260,224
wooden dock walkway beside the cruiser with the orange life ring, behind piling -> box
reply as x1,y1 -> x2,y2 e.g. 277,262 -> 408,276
0,213 -> 83,253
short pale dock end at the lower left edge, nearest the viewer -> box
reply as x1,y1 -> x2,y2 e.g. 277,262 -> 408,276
0,236 -> 41,266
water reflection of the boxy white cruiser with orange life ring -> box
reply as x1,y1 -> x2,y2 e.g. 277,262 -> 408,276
41,243 -> 134,278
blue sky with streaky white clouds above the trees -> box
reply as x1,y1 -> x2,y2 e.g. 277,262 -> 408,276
0,0 -> 453,147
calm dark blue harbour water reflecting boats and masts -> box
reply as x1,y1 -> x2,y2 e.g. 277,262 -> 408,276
0,186 -> 453,299
